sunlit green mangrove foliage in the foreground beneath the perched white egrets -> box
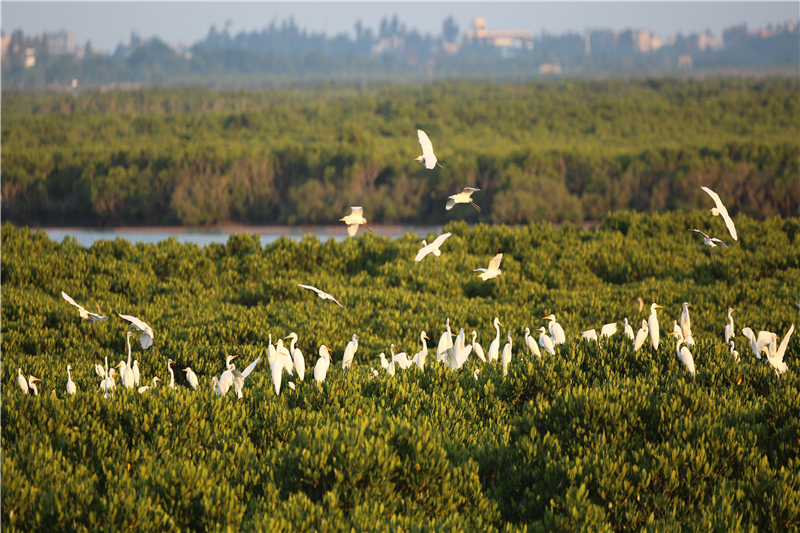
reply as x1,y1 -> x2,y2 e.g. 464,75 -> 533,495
0,211 -> 800,531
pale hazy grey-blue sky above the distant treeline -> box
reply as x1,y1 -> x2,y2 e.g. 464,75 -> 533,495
0,0 -> 800,51
